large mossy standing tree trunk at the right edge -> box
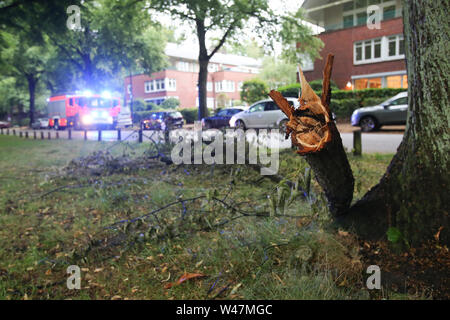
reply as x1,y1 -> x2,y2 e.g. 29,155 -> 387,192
338,0 -> 450,245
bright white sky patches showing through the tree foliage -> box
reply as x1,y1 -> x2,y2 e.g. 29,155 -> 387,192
152,0 -> 316,55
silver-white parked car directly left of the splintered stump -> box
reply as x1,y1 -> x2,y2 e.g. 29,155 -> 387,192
230,98 -> 299,131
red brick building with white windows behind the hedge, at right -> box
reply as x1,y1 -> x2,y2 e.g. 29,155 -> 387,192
302,0 -> 408,89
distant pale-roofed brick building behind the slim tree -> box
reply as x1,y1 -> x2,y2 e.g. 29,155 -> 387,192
124,43 -> 260,109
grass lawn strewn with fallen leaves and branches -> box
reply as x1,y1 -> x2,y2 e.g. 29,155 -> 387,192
0,136 -> 414,299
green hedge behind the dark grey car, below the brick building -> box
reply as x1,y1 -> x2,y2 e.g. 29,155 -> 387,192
278,81 -> 405,118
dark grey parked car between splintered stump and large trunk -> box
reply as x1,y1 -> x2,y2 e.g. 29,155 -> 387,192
351,92 -> 408,132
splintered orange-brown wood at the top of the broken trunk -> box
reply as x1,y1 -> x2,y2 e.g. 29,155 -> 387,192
269,57 -> 333,155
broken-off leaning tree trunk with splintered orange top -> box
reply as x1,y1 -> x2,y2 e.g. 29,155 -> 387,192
269,54 -> 354,216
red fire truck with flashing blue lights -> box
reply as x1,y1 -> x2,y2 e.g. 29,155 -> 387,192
47,92 -> 120,130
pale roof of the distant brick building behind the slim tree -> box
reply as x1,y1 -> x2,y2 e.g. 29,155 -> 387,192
165,42 -> 261,68
